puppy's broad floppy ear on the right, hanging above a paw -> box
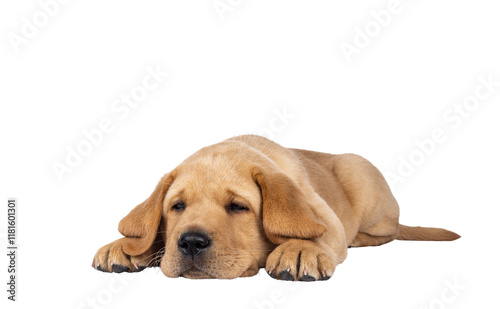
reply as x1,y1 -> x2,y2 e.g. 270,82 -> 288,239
253,169 -> 326,244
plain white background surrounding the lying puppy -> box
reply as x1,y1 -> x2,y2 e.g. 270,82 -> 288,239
0,0 -> 500,309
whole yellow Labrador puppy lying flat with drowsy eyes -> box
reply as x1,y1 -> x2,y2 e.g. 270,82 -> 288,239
92,135 -> 460,281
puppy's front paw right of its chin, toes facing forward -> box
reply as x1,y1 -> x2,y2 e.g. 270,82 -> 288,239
266,239 -> 335,281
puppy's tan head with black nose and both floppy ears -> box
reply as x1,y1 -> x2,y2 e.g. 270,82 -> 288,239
120,143 -> 326,278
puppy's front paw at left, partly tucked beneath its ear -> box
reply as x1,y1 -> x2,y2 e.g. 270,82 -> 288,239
92,239 -> 150,273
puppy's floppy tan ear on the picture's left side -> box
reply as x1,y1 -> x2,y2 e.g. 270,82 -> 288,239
118,172 -> 174,256
